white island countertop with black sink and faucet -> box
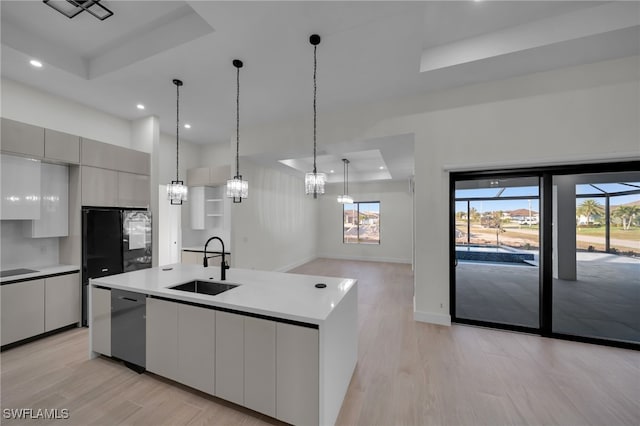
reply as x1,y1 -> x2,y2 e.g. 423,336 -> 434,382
90,264 -> 357,324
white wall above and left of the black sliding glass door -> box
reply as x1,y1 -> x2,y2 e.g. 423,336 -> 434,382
235,56 -> 640,324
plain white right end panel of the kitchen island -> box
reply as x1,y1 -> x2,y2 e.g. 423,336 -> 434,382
319,282 -> 358,425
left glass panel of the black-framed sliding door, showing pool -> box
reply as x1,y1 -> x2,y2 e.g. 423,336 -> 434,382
454,176 -> 540,329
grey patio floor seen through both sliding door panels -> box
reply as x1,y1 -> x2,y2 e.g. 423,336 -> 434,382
456,252 -> 640,342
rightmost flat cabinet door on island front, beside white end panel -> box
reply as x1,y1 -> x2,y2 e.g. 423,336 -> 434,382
276,323 -> 319,425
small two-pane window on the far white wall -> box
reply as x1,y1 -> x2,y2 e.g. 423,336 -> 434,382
342,201 -> 380,244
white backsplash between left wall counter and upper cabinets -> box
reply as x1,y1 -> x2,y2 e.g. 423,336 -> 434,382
0,220 -> 59,270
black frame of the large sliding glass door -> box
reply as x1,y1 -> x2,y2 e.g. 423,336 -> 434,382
449,161 -> 640,350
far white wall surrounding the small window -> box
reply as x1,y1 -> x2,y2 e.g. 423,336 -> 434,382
318,181 -> 413,263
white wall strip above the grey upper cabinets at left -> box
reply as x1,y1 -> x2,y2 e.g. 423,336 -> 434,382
2,78 -> 132,149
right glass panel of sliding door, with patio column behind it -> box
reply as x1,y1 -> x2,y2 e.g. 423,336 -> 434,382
553,172 -> 640,342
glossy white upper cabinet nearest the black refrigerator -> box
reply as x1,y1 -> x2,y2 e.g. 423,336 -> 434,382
25,163 -> 69,238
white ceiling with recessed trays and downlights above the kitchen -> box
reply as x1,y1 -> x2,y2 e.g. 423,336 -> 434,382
1,0 -> 640,179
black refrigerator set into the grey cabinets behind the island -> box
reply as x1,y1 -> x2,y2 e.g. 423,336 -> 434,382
82,207 -> 151,326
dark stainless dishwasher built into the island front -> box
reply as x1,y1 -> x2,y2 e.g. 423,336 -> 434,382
111,289 -> 147,373
